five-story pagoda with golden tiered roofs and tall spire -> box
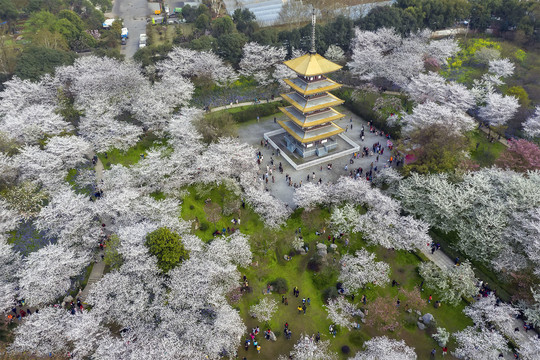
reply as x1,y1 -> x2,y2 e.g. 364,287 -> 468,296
279,15 -> 345,158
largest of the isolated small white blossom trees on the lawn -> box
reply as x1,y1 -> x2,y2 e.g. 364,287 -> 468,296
338,249 -> 390,292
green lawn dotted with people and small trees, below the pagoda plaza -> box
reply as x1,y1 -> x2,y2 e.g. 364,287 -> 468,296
182,186 -> 472,359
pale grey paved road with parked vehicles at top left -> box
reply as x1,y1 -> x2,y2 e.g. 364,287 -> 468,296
112,0 -> 150,58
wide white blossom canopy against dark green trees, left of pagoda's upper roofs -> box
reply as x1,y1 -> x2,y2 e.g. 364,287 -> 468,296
156,47 -> 238,86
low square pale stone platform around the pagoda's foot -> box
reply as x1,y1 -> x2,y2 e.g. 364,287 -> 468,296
264,129 -> 360,170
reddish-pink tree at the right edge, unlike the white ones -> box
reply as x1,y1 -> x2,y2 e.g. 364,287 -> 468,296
496,139 -> 540,173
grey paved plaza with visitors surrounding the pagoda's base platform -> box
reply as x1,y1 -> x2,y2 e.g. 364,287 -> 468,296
238,107 -> 391,209
